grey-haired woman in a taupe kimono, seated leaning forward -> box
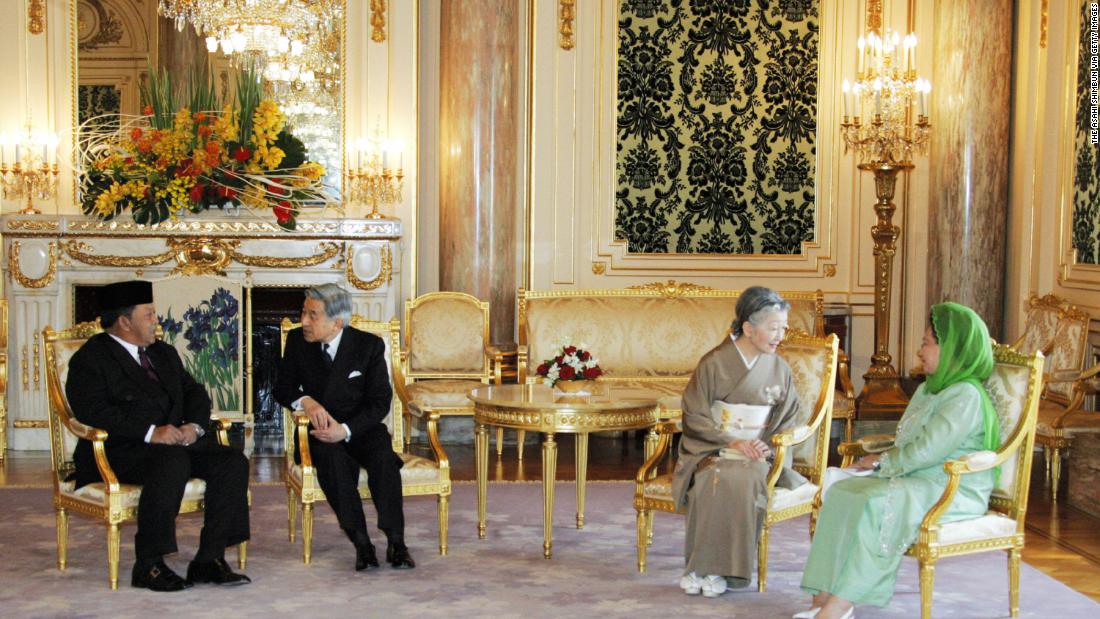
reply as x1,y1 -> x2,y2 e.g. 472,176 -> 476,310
672,286 -> 806,597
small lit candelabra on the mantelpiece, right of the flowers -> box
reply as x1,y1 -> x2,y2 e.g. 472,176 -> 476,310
344,136 -> 405,219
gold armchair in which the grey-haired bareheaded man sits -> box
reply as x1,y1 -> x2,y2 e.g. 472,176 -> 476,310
279,316 -> 451,563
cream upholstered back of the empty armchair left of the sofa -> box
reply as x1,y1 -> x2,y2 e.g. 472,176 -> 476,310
405,292 -> 491,379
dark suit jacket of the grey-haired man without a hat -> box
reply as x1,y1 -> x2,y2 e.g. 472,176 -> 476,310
275,327 -> 393,440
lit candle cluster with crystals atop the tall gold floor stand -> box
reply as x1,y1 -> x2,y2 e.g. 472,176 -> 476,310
840,30 -> 932,164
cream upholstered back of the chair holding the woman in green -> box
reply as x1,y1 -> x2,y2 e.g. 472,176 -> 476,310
985,344 -> 1043,511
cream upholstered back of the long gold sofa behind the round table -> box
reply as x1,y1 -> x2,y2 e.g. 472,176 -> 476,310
517,284 -> 824,382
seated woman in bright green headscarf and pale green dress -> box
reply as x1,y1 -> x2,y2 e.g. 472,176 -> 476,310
794,303 -> 1000,619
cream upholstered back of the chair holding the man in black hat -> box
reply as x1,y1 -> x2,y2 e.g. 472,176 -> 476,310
42,321 -> 102,487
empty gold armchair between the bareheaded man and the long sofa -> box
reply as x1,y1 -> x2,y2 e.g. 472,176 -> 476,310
399,292 -> 510,457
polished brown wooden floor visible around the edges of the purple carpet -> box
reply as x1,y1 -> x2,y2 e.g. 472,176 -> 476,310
0,436 -> 1100,601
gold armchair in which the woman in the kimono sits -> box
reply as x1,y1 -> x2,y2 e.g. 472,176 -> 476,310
634,333 -> 837,593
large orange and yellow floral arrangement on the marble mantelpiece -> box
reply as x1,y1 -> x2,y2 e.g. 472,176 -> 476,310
80,69 -> 328,230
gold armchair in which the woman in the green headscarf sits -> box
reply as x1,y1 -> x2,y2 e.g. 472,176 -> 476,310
840,345 -> 1043,619
